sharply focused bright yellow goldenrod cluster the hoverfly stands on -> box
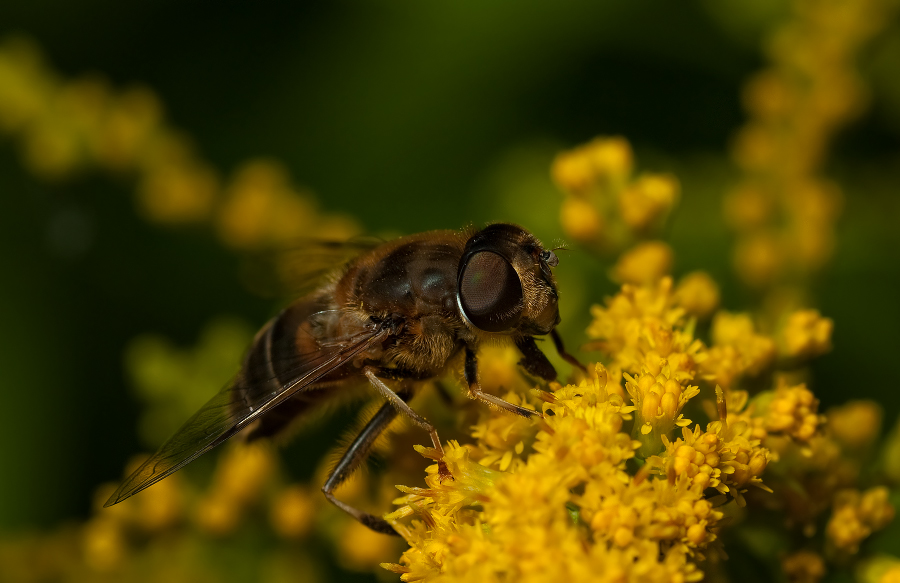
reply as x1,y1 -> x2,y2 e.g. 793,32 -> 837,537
383,274 -> 893,581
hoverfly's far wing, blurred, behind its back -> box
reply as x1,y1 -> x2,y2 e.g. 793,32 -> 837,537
240,237 -> 384,298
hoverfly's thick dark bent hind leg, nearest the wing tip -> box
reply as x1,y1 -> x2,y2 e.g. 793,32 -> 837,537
322,392 -> 412,535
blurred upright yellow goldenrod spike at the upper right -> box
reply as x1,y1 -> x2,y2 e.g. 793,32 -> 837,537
724,0 -> 895,288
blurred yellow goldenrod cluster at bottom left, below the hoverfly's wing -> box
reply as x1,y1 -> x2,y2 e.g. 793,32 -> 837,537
46,443 -> 398,583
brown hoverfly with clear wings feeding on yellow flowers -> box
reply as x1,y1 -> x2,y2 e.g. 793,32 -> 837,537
105,223 -> 581,534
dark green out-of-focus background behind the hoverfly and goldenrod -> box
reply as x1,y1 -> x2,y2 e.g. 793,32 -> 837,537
0,0 -> 900,580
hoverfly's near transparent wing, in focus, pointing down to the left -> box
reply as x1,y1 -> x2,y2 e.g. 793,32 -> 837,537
104,326 -> 388,507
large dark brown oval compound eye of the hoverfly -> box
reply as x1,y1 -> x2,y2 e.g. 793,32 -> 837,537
459,251 -> 522,332
